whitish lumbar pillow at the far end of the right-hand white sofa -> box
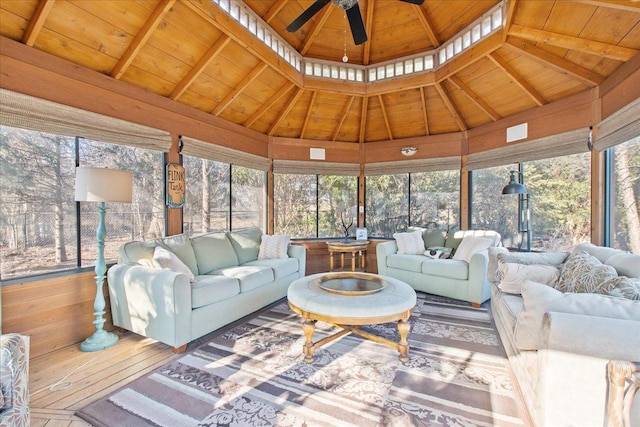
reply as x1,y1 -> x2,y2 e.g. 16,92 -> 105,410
496,262 -> 560,294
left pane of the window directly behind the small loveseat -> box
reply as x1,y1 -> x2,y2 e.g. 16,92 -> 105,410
365,174 -> 409,237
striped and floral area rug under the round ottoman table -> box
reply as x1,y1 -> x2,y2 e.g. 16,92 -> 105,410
77,293 -> 530,427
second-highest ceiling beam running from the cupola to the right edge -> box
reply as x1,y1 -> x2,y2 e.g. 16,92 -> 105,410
509,25 -> 638,62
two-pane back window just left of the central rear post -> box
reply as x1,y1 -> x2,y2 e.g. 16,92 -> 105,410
273,173 -> 358,238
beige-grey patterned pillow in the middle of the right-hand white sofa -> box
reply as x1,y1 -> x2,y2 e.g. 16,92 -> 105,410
556,252 -> 618,292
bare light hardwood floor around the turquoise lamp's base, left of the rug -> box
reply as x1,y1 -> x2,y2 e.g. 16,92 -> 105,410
29,332 -> 200,427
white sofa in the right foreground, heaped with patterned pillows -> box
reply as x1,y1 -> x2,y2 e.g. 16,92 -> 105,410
489,243 -> 640,427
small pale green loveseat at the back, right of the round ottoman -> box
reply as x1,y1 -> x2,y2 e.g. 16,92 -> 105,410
376,229 -> 500,306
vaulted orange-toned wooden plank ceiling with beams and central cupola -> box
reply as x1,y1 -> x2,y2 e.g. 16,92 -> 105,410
0,0 -> 640,143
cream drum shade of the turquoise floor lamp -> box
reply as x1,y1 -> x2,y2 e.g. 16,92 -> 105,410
76,167 -> 133,203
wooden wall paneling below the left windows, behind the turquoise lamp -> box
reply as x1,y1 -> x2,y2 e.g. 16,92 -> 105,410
2,271 -> 113,357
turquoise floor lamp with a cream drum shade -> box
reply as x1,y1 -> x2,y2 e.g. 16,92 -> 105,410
75,167 -> 133,351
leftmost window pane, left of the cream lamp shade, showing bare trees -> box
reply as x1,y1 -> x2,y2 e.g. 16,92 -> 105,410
0,126 -> 76,280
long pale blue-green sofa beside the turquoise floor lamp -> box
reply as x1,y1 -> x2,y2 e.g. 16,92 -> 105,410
107,228 -> 306,352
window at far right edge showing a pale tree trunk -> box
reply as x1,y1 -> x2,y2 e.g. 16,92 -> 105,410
609,136 -> 640,254
